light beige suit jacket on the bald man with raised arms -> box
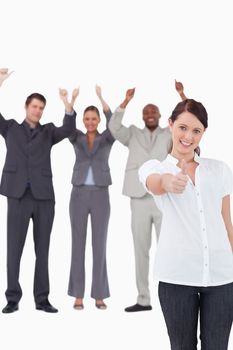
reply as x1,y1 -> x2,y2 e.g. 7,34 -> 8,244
109,107 -> 171,198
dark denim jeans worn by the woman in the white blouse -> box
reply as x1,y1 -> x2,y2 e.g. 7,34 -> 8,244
159,282 -> 233,350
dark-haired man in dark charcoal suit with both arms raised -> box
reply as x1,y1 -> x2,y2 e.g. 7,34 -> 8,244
0,69 -> 78,313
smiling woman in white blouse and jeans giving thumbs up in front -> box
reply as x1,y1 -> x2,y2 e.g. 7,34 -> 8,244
139,99 -> 233,350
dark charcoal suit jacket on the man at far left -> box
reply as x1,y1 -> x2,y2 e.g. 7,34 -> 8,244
0,113 -> 76,199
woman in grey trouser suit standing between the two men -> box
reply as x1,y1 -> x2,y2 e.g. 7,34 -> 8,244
68,86 -> 114,310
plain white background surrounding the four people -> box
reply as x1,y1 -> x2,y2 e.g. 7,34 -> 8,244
0,0 -> 233,350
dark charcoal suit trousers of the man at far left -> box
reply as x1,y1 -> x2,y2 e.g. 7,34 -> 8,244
6,189 -> 54,303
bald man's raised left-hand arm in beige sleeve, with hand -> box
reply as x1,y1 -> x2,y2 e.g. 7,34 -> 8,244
108,89 -> 135,146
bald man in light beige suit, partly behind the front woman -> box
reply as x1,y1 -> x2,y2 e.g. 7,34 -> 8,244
109,82 -> 186,312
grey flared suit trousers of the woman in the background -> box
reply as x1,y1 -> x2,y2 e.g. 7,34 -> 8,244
68,185 -> 110,299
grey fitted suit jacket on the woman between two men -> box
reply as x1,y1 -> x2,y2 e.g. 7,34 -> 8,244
69,111 -> 115,186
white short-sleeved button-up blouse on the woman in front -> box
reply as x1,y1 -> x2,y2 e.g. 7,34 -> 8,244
139,154 -> 233,286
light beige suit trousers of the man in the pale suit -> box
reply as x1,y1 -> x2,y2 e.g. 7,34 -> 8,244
131,194 -> 162,305
